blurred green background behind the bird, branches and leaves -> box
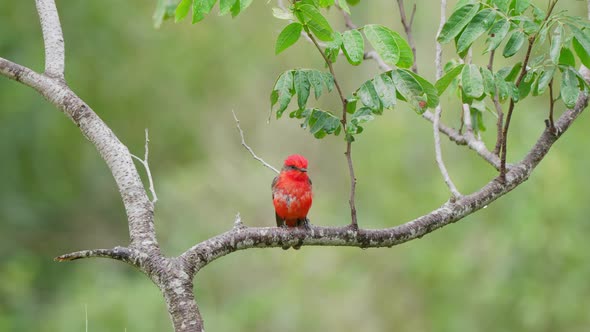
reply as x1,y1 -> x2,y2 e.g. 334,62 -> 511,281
0,0 -> 590,332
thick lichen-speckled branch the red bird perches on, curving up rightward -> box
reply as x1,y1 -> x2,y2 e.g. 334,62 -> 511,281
180,92 -> 588,272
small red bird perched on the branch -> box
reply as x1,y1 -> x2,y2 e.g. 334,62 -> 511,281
272,154 -> 312,227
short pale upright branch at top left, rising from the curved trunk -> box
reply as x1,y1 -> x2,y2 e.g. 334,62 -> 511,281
35,0 -> 65,80
